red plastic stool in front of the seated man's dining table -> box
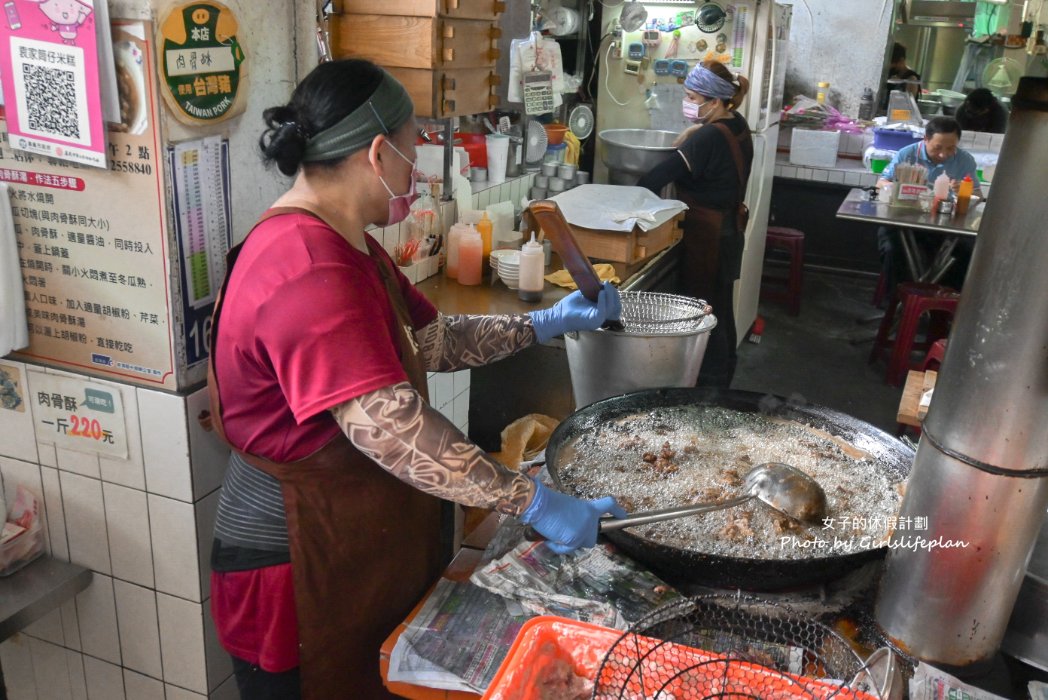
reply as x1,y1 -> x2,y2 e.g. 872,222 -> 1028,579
870,282 -> 961,387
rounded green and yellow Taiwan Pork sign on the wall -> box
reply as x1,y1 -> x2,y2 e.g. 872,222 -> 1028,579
157,0 -> 246,124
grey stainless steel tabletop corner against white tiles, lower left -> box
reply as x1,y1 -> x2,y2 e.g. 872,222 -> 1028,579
0,556 -> 91,641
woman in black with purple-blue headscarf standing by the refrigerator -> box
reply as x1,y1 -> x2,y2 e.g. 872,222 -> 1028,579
637,61 -> 754,389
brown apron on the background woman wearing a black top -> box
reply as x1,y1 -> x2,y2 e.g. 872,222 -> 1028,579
677,122 -> 749,301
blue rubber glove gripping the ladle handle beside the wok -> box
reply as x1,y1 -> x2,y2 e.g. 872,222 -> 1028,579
521,481 -> 626,554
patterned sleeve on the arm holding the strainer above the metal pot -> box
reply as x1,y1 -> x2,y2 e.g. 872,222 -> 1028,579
415,313 -> 536,372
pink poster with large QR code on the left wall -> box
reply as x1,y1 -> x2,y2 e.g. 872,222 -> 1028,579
0,0 -> 108,168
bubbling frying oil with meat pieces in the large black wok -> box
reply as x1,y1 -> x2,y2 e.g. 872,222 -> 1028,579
558,406 -> 902,560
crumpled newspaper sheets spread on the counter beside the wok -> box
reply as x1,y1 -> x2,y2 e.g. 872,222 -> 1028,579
388,518 -> 680,693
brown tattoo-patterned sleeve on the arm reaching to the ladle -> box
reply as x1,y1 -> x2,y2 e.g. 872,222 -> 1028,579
331,381 -> 533,516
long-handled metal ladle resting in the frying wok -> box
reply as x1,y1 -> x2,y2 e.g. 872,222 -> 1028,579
601,462 -> 826,532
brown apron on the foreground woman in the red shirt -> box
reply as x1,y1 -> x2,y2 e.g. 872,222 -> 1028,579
208,207 -> 450,700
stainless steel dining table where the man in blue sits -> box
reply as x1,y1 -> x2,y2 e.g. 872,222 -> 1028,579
837,188 -> 984,282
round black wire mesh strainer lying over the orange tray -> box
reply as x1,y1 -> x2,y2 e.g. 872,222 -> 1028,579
593,594 -> 878,700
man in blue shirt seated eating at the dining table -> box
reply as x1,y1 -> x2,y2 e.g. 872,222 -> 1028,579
877,116 -> 982,303
